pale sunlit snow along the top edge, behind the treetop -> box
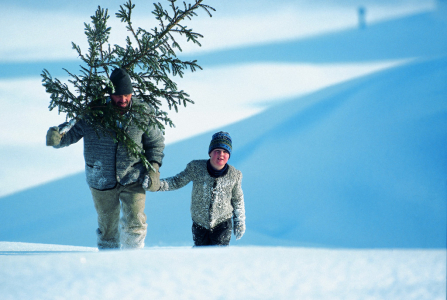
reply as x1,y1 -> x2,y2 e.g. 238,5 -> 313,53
0,0 -> 436,61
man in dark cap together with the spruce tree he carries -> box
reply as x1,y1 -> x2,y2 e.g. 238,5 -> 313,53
41,0 -> 214,249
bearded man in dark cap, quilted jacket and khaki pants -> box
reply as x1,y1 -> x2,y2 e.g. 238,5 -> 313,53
47,69 -> 165,249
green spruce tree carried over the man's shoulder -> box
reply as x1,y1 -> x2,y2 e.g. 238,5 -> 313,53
41,0 -> 214,168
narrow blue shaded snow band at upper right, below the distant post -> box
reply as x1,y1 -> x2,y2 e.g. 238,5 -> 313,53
189,11 -> 447,66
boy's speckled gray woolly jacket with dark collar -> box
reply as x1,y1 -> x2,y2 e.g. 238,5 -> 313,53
160,160 -> 245,229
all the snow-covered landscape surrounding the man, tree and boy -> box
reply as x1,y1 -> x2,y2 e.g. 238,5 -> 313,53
0,0 -> 447,300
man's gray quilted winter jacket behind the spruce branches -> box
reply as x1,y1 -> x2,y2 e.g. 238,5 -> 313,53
54,98 -> 165,190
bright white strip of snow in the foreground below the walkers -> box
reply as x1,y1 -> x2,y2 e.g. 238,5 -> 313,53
0,243 -> 446,300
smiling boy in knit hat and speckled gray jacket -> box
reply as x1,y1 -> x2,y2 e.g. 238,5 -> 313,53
153,131 -> 245,246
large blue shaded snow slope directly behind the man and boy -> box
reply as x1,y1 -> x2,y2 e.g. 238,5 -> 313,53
0,58 -> 447,248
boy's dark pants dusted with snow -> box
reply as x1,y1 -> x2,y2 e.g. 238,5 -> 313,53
192,219 -> 233,247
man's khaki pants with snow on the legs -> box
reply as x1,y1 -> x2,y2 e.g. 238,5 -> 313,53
90,183 -> 147,249
